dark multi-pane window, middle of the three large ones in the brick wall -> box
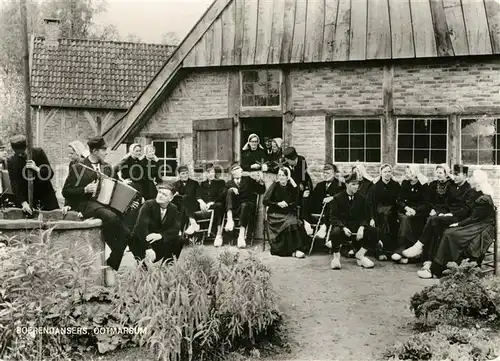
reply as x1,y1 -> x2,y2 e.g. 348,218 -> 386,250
397,118 -> 448,164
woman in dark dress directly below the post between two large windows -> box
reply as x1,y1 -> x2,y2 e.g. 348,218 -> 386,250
368,164 -> 401,260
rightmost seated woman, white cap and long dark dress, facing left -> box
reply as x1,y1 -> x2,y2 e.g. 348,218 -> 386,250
417,170 -> 496,278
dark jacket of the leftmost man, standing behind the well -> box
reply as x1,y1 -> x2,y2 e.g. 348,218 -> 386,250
7,148 -> 59,211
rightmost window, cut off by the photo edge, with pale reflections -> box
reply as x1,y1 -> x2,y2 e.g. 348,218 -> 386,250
460,117 -> 500,165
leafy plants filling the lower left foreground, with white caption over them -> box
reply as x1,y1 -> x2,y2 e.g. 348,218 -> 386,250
0,231 -> 284,361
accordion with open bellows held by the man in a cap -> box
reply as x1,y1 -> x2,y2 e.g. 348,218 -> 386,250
94,177 -> 139,213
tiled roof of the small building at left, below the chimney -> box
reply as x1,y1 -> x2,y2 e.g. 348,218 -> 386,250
31,37 -> 175,109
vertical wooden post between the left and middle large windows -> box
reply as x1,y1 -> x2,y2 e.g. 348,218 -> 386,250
382,65 -> 396,164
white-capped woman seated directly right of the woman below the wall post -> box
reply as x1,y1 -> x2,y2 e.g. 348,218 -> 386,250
391,164 -> 428,263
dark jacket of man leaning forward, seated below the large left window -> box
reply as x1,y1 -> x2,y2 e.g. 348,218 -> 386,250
330,191 -> 368,232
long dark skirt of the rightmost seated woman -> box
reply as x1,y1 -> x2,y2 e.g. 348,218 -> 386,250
434,221 -> 496,266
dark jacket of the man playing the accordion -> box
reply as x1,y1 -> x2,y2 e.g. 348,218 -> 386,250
62,158 -> 117,212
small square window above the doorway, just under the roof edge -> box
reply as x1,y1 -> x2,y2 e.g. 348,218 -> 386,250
241,70 -> 281,107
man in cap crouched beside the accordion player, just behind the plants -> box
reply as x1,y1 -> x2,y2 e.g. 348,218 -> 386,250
131,182 -> 183,262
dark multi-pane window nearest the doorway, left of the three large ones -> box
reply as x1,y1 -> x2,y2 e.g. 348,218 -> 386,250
333,118 -> 381,162
